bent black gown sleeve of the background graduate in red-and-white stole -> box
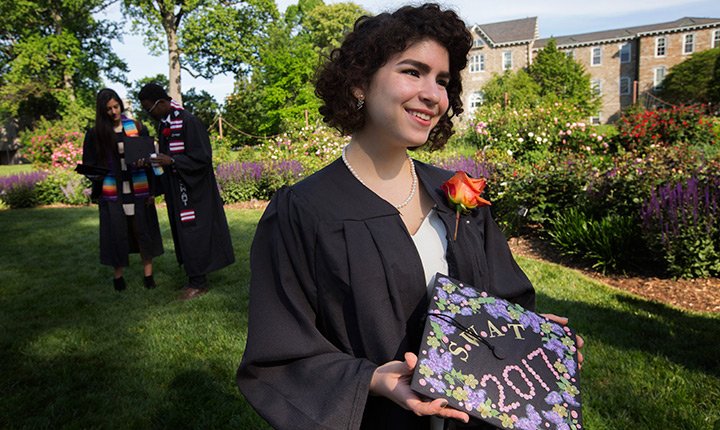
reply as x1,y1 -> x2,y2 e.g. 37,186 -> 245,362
173,115 -> 212,188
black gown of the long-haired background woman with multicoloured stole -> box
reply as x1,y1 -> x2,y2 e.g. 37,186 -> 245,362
83,127 -> 164,267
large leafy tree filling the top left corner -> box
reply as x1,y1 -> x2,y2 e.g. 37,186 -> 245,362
0,0 -> 127,127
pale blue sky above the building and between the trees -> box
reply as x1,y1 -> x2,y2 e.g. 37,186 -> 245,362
98,0 -> 720,102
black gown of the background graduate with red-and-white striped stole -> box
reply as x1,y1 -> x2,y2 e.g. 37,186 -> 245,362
158,109 -> 235,276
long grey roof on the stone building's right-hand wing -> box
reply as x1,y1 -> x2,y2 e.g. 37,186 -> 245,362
535,17 -> 720,49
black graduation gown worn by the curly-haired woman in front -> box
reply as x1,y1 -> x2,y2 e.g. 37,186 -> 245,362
237,160 -> 535,430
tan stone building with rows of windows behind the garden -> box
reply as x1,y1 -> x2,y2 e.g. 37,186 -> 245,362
463,17 -> 720,123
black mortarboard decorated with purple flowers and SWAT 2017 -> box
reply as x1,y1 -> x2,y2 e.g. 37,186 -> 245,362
411,273 -> 583,430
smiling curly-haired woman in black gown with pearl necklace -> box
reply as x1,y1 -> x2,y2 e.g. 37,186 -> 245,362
237,4 -> 584,430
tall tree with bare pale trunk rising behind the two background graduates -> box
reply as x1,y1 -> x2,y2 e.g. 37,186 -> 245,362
123,0 -> 277,102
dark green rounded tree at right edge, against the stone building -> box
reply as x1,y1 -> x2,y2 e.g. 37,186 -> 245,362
658,47 -> 720,104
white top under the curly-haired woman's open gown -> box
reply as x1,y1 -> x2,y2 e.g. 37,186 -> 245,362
412,208 -> 448,430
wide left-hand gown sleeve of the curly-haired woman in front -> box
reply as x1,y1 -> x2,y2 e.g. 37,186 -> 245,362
237,188 -> 377,430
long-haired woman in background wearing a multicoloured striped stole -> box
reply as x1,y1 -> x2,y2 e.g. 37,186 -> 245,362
80,88 -> 163,291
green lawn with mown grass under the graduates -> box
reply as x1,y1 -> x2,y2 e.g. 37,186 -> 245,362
0,207 -> 720,430
